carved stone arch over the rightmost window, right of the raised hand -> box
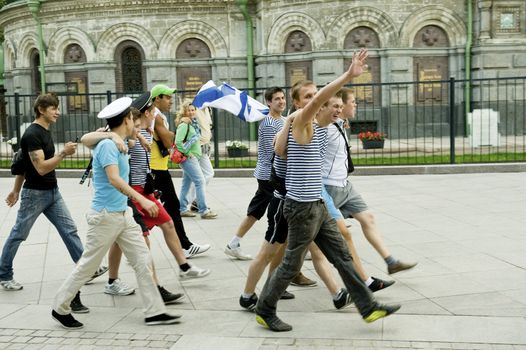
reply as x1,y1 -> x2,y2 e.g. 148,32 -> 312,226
400,5 -> 466,47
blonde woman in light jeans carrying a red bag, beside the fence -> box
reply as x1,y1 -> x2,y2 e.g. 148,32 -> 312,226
175,100 -> 217,219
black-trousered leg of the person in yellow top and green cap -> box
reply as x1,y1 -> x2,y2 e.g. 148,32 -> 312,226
152,170 -> 192,249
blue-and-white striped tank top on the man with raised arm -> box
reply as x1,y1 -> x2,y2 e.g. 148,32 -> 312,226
286,124 -> 327,202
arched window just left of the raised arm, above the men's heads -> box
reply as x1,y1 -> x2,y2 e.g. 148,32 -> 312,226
284,30 -> 312,86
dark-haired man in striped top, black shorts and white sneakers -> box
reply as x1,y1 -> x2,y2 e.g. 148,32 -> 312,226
225,87 -> 286,260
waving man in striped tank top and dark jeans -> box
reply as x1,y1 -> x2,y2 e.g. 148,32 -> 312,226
256,50 -> 400,332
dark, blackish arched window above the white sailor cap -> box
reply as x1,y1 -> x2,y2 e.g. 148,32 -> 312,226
115,40 -> 146,93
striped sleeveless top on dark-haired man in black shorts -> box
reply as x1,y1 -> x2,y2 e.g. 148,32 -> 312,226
254,115 -> 285,180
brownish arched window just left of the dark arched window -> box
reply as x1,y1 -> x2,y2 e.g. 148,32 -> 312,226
64,44 -> 89,112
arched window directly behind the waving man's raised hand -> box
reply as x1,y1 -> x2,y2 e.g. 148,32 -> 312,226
343,26 -> 381,106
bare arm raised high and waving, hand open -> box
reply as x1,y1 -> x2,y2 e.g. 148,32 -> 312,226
292,49 -> 368,140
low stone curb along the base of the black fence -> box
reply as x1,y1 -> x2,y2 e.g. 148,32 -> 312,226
0,163 -> 526,179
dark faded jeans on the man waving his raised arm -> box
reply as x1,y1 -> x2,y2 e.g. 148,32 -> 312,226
256,198 -> 376,317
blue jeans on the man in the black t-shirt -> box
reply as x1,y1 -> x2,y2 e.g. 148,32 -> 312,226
0,188 -> 83,281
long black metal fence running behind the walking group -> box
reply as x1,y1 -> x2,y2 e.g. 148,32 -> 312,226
0,77 -> 526,168
